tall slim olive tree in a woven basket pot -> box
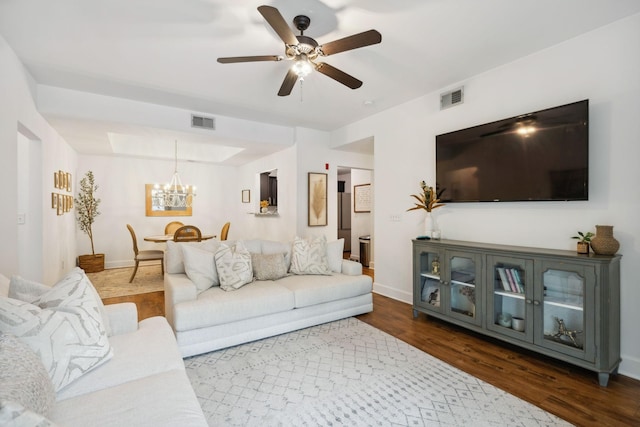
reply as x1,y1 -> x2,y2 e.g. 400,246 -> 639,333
74,171 -> 104,273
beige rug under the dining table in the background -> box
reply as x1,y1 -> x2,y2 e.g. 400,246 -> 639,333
87,264 -> 164,298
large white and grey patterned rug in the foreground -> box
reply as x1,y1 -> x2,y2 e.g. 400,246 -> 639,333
185,318 -> 570,426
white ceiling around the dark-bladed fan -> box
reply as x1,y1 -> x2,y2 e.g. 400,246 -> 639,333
0,0 -> 640,163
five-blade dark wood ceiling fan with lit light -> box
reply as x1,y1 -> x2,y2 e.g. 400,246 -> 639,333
218,6 -> 382,96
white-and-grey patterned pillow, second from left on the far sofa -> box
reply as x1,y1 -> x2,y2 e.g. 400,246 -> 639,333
215,242 -> 253,291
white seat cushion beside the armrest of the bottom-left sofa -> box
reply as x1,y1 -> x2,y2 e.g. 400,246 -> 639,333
57,316 -> 184,401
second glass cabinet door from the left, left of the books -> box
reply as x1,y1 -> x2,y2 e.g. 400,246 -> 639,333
447,252 -> 482,324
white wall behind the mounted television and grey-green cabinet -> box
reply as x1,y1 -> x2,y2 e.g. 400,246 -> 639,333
332,15 -> 640,378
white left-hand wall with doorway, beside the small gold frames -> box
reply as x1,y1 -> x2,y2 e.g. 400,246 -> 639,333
0,36 -> 77,284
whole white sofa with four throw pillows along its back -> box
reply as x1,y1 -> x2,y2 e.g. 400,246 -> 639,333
164,238 -> 373,357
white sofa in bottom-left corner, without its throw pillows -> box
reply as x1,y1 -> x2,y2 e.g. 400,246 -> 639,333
0,274 -> 207,427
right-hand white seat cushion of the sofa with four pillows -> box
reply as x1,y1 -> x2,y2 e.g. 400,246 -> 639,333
278,274 -> 371,308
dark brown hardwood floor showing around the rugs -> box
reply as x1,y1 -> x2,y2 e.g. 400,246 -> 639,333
104,269 -> 640,426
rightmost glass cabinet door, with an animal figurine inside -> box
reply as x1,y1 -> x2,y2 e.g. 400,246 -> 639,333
536,265 -> 595,360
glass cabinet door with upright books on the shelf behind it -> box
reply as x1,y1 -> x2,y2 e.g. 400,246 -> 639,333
487,256 -> 533,341
